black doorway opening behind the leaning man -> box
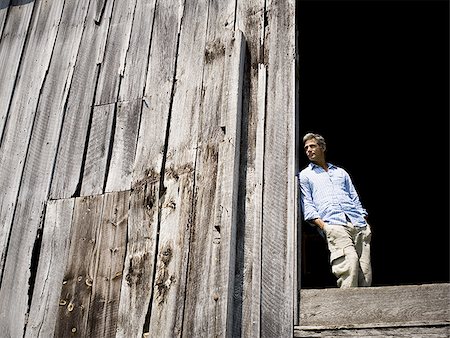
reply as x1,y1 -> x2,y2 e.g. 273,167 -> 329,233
297,0 -> 450,288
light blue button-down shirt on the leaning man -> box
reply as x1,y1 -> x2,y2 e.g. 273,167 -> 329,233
299,163 -> 367,226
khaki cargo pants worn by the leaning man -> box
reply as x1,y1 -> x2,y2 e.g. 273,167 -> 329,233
324,222 -> 372,288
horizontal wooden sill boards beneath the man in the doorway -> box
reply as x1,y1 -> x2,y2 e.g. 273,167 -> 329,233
295,283 -> 450,338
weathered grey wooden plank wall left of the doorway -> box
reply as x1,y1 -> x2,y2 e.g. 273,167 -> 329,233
0,0 -> 297,337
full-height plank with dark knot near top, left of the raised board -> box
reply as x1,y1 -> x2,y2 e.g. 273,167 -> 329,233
183,1 -> 234,337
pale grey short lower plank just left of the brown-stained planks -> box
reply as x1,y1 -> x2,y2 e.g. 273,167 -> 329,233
25,199 -> 75,338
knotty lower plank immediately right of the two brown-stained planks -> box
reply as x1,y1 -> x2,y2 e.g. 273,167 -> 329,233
116,185 -> 159,338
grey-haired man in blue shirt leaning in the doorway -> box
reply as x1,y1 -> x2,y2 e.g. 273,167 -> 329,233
299,133 -> 372,288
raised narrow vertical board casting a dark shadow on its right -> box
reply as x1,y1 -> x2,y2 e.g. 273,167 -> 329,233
212,30 -> 246,337
